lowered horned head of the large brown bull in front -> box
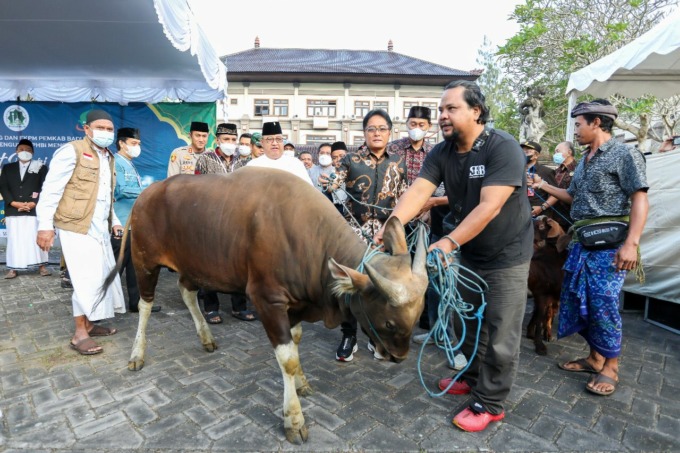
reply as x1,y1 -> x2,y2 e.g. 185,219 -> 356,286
328,217 -> 427,362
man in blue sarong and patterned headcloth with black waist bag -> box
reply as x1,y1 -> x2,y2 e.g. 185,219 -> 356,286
534,99 -> 649,396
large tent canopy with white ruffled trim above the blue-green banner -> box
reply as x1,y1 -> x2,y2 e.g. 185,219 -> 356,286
0,0 -> 227,104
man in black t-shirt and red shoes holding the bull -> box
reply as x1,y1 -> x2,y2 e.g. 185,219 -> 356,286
375,81 -> 533,431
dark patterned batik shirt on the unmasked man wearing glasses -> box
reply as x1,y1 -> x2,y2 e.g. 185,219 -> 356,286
334,147 -> 406,237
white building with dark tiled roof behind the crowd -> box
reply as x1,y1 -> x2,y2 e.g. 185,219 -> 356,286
222,38 -> 479,146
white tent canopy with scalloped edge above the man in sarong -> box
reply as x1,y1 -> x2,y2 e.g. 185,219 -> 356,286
566,8 -> 680,140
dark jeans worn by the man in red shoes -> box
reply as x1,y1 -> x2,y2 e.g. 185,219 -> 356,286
454,254 -> 529,414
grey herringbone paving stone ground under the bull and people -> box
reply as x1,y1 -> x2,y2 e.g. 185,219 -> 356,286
0,250 -> 680,452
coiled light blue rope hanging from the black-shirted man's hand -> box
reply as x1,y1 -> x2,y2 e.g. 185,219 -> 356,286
418,238 -> 489,397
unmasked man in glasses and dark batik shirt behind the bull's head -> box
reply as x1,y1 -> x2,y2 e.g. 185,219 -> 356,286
331,110 -> 406,362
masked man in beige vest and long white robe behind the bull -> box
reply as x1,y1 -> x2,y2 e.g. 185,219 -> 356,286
36,110 -> 125,355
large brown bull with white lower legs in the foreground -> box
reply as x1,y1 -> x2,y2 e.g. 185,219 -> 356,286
105,168 -> 427,443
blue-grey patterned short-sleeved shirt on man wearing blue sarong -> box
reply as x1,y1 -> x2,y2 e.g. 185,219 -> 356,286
567,138 -> 649,221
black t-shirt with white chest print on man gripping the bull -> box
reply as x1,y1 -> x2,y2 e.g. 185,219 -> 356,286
419,129 -> 534,269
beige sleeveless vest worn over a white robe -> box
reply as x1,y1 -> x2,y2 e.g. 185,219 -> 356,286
54,137 -> 116,234
